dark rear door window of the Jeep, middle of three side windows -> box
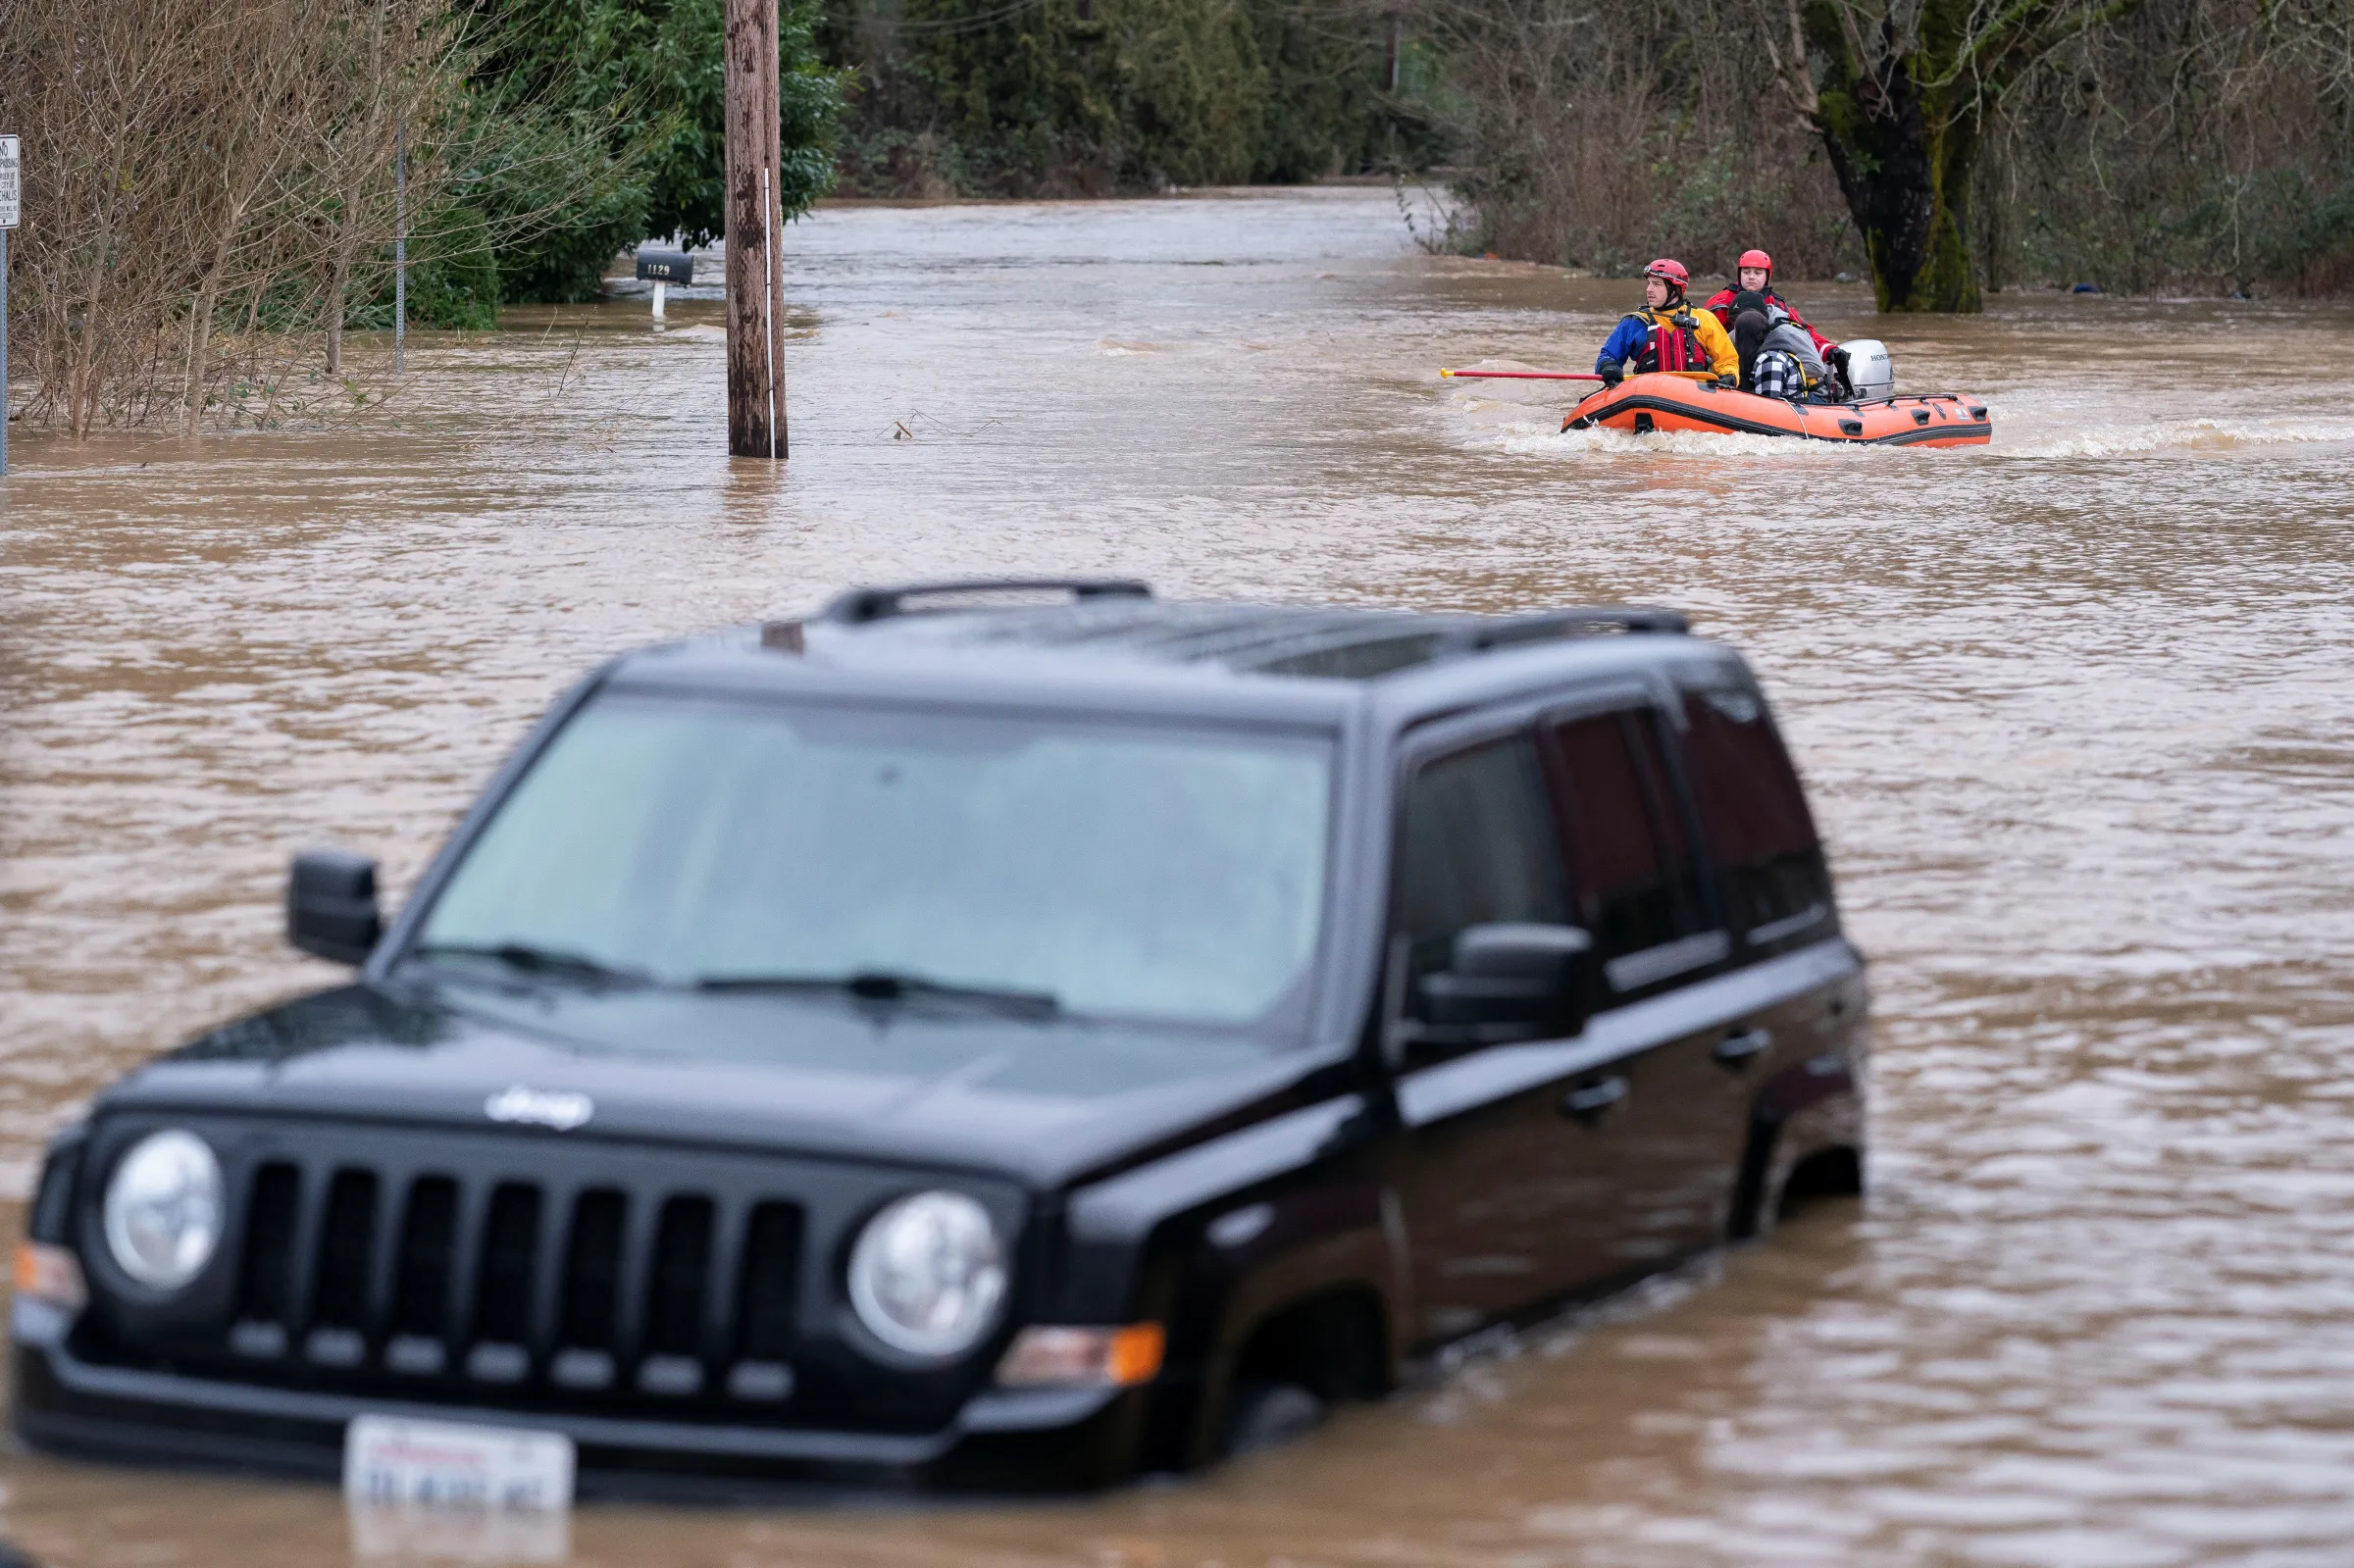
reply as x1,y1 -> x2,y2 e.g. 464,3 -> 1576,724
1549,711 -> 1707,963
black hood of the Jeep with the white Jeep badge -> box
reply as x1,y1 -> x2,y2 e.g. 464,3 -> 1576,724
110,985 -> 1330,1189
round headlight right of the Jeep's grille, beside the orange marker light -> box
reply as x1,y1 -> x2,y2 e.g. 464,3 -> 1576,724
849,1191 -> 1005,1356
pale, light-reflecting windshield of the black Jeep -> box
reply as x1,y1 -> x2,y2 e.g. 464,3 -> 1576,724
410,697 -> 1332,1027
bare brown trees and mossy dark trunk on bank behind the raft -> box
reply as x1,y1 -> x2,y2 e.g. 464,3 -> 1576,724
1417,0 -> 2354,311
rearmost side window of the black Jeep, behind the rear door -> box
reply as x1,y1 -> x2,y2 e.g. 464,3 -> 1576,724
1683,687 -> 1831,951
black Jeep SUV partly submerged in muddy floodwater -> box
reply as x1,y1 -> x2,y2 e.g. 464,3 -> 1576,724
12,582 -> 1865,1486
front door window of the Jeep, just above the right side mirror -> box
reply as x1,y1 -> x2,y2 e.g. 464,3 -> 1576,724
1396,734 -> 1570,1005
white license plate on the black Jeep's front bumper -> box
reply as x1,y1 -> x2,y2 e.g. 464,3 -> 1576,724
343,1415 -> 575,1514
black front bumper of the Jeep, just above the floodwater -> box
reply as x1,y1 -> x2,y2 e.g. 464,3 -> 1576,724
10,1297 -> 1147,1497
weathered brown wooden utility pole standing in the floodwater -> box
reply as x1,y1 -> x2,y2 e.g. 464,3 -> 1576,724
725,0 -> 784,459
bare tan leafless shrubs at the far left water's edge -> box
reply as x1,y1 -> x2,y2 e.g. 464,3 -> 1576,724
0,0 -> 469,435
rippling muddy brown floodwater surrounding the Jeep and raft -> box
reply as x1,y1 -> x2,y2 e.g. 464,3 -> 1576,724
0,190 -> 2354,1568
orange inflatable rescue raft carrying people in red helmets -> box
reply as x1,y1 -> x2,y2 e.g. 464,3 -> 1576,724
1561,375 -> 1994,447
